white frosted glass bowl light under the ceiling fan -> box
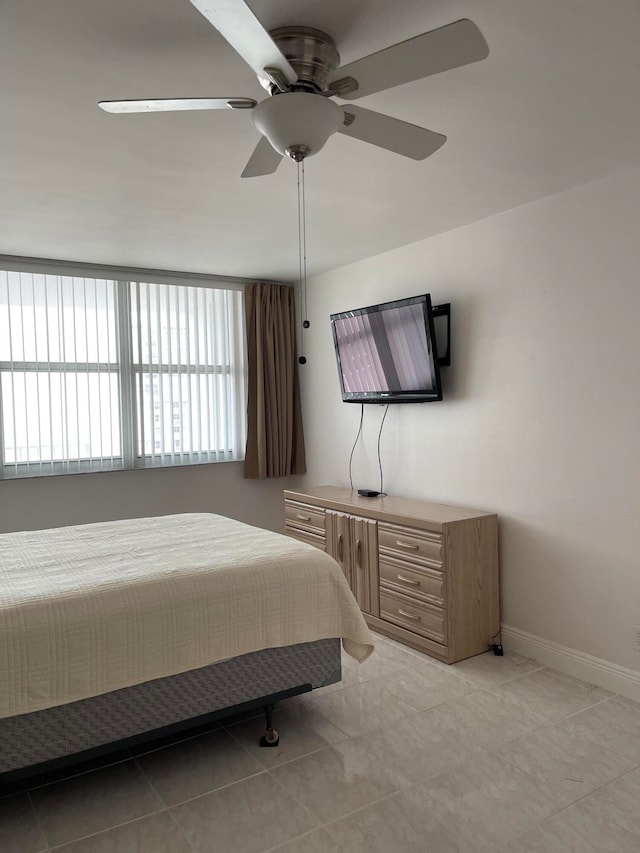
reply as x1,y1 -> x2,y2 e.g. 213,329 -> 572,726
251,92 -> 344,156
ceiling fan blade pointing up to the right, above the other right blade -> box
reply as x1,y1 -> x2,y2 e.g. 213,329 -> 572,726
328,18 -> 489,100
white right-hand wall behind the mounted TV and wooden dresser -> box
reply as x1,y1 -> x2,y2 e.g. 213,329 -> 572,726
301,170 -> 640,669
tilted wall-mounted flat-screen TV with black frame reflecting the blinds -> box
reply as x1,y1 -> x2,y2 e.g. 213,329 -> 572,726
331,293 -> 442,403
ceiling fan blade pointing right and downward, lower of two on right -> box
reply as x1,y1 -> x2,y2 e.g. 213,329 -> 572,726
338,107 -> 447,160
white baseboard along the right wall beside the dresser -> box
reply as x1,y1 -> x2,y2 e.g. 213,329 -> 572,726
502,625 -> 640,702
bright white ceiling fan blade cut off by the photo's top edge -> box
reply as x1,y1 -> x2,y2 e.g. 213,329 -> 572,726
191,0 -> 298,89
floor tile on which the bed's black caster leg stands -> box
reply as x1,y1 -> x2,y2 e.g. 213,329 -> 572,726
229,700 -> 347,768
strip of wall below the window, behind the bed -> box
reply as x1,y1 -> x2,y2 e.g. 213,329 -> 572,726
0,462 -> 300,533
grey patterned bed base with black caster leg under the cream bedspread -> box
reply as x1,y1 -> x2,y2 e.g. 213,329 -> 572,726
0,639 -> 341,793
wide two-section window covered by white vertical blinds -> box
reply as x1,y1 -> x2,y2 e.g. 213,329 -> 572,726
0,264 -> 246,477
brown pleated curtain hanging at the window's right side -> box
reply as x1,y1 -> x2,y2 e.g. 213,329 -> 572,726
244,284 -> 306,480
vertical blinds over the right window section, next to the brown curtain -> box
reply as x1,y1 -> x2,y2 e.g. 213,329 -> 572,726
132,282 -> 246,465
